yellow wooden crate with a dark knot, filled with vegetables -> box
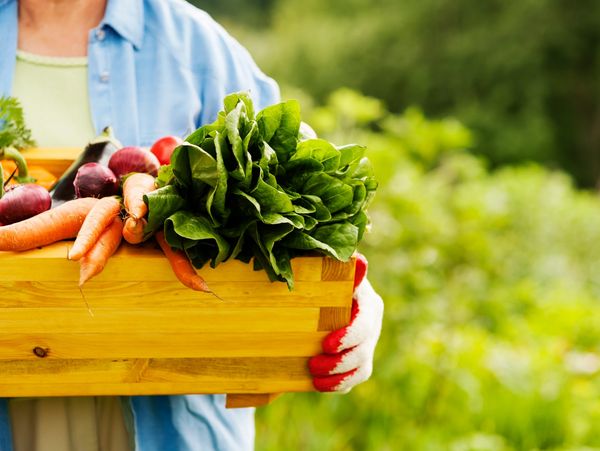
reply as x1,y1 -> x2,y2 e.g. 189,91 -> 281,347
0,150 -> 354,407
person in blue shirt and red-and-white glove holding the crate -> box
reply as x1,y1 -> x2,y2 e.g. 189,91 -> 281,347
0,0 -> 382,451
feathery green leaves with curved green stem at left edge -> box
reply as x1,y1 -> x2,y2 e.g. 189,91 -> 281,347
0,97 -> 35,183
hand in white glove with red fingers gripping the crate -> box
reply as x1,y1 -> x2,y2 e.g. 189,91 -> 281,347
308,254 -> 383,393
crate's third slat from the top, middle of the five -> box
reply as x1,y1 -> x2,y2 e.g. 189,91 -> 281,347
0,306 -> 319,337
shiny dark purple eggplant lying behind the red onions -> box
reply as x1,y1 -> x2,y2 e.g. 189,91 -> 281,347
50,127 -> 122,207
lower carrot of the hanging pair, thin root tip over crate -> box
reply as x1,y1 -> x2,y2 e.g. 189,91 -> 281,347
79,215 -> 123,287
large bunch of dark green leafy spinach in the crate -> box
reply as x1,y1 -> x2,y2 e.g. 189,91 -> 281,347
145,93 -> 377,288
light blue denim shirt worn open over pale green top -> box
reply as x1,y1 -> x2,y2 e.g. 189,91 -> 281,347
0,0 -> 279,451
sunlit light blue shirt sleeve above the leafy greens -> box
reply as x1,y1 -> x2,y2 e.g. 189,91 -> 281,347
197,17 -> 281,126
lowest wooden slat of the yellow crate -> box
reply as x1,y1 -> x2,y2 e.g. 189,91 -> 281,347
0,357 -> 312,402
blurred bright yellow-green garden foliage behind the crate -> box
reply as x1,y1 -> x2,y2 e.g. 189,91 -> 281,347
257,91 -> 600,451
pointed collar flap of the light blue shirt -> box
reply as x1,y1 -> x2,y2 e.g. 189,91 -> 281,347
101,0 -> 144,49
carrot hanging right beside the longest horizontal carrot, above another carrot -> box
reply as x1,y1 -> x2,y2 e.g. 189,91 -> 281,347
69,197 -> 121,260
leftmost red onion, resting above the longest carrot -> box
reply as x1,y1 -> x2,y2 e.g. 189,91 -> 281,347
0,183 -> 52,225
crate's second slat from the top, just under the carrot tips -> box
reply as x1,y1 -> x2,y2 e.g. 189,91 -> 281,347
0,279 -> 352,309
